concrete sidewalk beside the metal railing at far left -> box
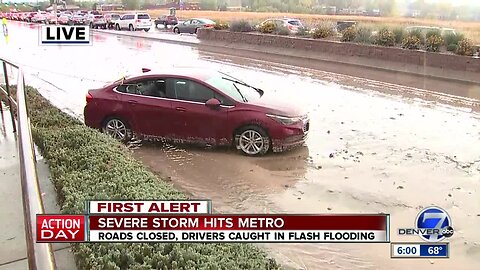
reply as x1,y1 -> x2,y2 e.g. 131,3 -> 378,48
0,104 -> 76,270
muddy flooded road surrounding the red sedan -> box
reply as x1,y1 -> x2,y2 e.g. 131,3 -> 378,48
0,23 -> 480,269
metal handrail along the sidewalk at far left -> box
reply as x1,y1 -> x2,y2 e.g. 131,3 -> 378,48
0,59 -> 56,270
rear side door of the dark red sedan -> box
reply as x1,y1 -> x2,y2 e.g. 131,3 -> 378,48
116,76 -> 172,137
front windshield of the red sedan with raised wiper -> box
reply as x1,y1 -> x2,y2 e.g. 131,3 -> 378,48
206,73 -> 262,102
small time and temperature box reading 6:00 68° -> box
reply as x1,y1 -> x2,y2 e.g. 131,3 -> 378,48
391,243 -> 450,258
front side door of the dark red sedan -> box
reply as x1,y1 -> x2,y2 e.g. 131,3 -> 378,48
167,78 -> 230,145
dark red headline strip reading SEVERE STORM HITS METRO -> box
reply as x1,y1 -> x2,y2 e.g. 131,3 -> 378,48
89,215 -> 387,231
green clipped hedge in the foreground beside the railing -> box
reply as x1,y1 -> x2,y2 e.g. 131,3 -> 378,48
2,87 -> 280,270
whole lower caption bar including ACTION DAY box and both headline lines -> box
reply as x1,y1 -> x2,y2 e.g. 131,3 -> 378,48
37,214 -> 390,243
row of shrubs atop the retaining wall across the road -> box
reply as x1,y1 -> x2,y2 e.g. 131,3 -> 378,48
215,20 -> 476,56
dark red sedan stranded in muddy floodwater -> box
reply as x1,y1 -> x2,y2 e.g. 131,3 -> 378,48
84,68 -> 309,156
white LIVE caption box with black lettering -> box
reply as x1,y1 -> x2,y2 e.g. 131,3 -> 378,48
40,25 -> 92,45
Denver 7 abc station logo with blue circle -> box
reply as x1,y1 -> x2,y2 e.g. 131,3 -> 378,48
398,206 -> 453,242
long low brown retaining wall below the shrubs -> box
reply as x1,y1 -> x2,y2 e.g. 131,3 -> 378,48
197,29 -> 480,83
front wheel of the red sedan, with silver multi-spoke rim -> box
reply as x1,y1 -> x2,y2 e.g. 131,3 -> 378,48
235,125 -> 271,156
